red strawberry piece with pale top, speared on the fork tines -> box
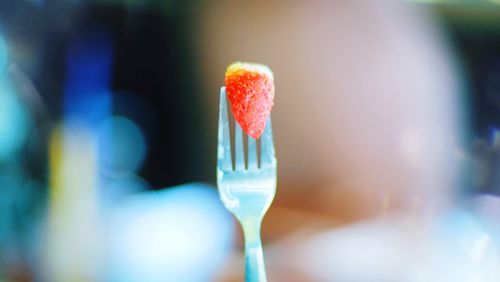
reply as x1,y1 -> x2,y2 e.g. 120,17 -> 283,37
225,62 -> 274,139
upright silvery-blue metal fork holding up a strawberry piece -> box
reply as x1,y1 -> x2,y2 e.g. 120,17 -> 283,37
217,87 -> 277,282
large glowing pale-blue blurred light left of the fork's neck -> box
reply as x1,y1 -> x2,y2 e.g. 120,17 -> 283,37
107,184 -> 234,282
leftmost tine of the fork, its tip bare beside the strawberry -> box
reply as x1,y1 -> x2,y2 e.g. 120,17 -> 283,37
217,87 -> 232,171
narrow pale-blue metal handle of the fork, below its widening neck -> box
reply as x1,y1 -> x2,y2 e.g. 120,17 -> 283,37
243,222 -> 267,282
